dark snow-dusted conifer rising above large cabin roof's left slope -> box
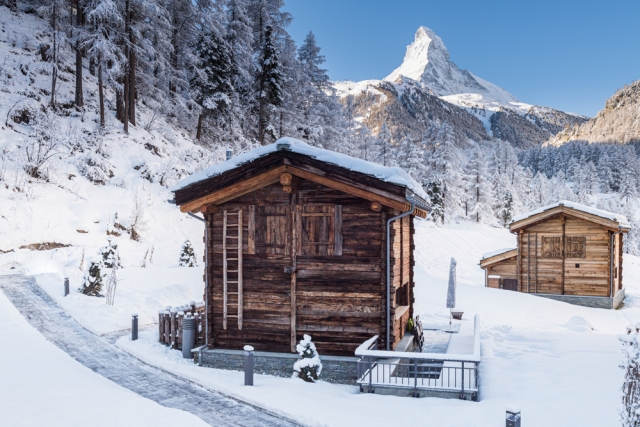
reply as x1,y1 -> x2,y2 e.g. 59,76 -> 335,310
190,31 -> 233,139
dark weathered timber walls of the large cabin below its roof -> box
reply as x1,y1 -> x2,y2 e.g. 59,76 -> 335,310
206,180 -> 414,356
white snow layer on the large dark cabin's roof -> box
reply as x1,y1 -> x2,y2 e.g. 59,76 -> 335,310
171,138 -> 428,200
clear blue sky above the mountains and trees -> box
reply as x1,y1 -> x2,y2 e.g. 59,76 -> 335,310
284,0 -> 640,117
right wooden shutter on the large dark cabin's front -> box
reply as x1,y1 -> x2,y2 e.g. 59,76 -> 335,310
298,205 -> 342,256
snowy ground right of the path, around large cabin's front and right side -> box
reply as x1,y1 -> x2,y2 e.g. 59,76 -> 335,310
107,221 -> 640,427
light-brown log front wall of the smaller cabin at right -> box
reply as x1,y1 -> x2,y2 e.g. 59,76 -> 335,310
518,216 -> 610,296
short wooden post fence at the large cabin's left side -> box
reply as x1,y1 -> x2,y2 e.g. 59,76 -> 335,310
158,301 -> 206,350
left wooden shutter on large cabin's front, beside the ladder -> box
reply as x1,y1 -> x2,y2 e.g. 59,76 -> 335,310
255,205 -> 291,255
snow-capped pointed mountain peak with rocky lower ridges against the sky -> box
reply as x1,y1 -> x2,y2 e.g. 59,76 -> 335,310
334,27 -> 586,148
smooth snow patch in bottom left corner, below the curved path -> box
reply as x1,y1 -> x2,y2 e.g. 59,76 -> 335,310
0,282 -> 207,427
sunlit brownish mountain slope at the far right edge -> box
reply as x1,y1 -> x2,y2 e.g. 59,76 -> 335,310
547,80 -> 640,146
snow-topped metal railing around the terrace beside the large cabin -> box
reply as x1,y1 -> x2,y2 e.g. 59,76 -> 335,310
355,315 -> 481,400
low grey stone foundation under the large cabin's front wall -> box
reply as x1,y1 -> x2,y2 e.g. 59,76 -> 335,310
193,348 -> 358,385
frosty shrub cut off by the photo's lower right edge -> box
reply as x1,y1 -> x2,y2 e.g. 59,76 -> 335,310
620,324 -> 640,427
